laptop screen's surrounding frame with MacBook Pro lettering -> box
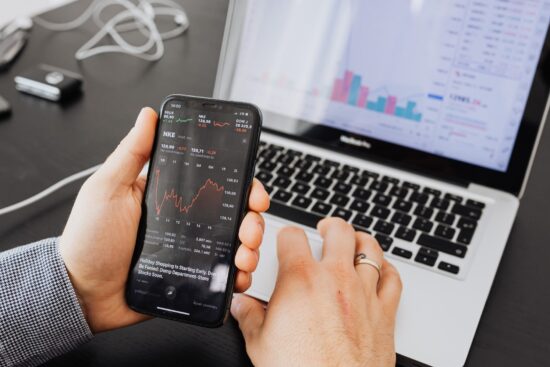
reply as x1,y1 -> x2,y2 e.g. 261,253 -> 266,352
214,0 -> 550,196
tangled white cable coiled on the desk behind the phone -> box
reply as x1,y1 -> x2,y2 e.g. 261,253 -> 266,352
35,0 -> 189,61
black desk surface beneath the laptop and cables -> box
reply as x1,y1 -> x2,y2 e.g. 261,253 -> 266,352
0,0 -> 550,366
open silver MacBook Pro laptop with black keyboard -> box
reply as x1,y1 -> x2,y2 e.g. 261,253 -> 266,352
215,0 -> 550,366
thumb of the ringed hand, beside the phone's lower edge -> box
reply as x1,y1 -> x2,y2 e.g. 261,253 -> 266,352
231,294 -> 265,344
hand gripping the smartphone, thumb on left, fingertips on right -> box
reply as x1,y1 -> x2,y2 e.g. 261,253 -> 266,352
59,108 -> 269,333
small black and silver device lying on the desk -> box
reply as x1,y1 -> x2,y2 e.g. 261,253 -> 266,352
14,64 -> 82,102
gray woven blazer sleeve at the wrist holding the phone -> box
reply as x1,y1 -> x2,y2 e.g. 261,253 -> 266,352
0,238 -> 92,367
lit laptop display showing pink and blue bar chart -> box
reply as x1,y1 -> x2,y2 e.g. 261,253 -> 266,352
230,0 -> 550,172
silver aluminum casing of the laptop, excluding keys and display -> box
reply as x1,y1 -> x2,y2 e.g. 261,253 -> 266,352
215,1 -> 548,366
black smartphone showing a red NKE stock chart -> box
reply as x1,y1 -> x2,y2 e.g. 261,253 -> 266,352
126,95 -> 262,327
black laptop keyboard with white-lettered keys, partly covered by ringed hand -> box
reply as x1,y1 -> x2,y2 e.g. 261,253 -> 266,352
256,142 -> 485,274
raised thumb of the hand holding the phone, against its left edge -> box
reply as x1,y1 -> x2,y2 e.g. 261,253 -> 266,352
98,107 -> 157,186
